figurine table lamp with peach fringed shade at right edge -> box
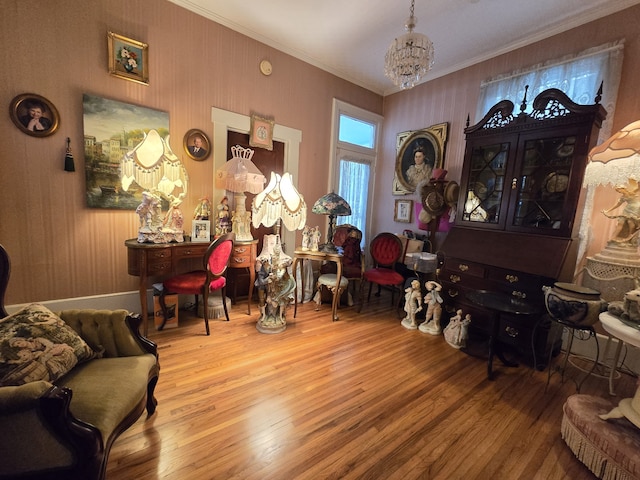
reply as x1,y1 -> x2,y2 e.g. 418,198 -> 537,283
583,120 -> 640,301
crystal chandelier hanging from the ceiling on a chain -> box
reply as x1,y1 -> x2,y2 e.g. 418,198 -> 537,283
384,0 -> 435,90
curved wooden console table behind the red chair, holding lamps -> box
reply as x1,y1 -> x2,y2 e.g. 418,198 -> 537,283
124,238 -> 258,336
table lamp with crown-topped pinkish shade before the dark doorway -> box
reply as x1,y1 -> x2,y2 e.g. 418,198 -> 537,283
216,145 -> 267,242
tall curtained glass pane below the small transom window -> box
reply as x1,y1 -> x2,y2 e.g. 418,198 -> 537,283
336,159 -> 371,245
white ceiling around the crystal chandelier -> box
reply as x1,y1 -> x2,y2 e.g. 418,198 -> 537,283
170,0 -> 640,95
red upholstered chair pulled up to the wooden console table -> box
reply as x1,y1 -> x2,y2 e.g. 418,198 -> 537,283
158,233 -> 235,335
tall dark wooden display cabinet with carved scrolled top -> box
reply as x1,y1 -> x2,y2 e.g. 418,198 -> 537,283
439,89 -> 606,365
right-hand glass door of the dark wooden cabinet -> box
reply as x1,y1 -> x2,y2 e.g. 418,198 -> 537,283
507,135 -> 576,230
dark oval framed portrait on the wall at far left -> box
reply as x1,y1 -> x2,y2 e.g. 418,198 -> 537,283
9,93 -> 60,137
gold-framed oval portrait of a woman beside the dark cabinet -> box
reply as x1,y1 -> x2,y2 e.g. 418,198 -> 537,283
393,123 -> 448,195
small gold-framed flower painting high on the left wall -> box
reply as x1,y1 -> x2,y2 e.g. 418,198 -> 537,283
107,32 -> 149,85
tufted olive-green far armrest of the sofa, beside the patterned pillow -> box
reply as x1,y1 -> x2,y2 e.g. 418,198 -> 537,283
58,309 -> 158,358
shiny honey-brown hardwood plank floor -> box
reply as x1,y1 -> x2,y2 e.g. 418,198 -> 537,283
107,293 -> 634,480
